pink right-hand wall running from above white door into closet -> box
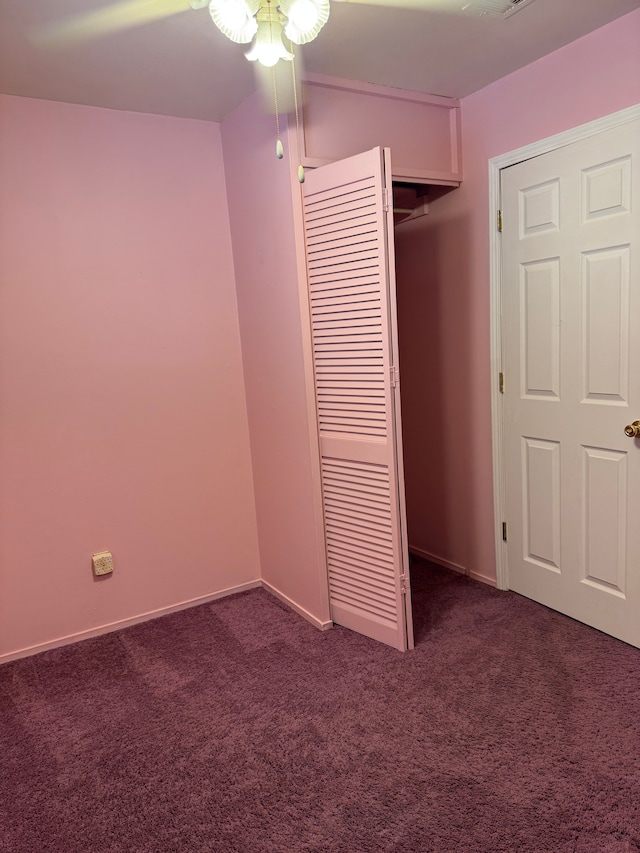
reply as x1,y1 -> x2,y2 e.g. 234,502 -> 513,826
397,10 -> 640,578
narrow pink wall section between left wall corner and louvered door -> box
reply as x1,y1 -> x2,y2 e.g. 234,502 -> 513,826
222,97 -> 329,622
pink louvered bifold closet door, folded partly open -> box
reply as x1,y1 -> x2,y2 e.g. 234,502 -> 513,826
304,148 -> 413,650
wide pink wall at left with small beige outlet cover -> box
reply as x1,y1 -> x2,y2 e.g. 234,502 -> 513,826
0,96 -> 260,660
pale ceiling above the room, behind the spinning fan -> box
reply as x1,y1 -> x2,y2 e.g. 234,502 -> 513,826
0,0 -> 640,121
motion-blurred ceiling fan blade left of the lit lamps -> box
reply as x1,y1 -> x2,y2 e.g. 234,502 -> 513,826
31,0 -> 196,46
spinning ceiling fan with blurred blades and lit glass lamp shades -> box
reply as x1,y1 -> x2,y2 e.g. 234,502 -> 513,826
33,0 -> 532,67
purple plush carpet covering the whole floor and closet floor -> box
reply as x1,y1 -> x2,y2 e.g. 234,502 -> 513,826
0,563 -> 640,853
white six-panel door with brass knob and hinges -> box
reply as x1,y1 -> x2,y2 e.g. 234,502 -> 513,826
501,115 -> 640,647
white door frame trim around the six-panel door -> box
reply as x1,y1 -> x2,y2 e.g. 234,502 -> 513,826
489,104 -> 640,589
